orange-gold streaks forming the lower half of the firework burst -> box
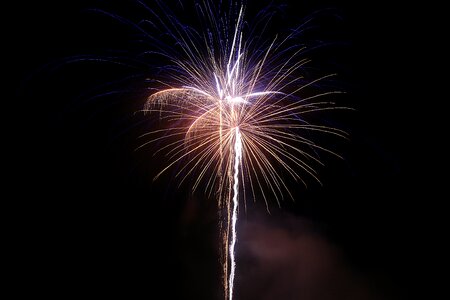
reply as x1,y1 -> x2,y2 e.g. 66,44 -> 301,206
142,88 -> 346,204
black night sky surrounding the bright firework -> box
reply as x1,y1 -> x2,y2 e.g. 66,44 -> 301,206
11,1 -> 438,299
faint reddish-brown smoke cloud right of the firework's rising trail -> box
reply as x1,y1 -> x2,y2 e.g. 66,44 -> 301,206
236,215 -> 387,300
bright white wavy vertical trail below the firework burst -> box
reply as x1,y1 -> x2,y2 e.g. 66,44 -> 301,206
229,127 -> 242,300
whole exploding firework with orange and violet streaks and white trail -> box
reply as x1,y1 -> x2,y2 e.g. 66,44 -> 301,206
130,1 -> 346,300
